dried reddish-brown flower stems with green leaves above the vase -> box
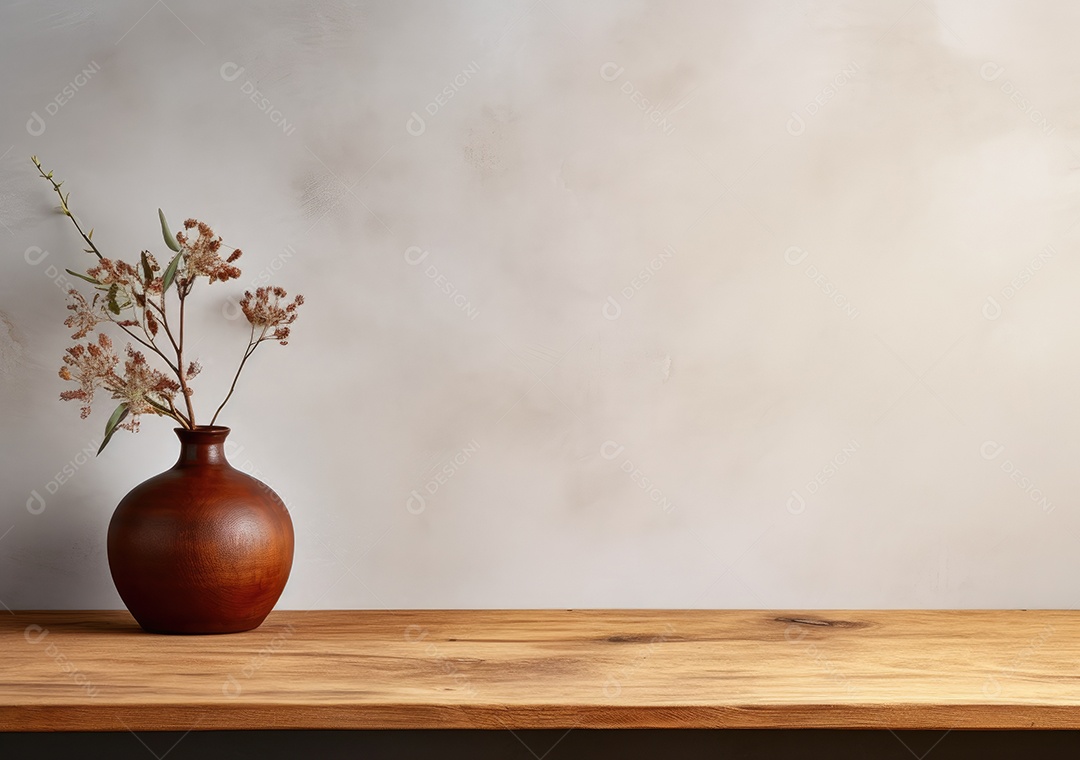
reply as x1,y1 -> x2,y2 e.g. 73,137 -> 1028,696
31,157 -> 303,453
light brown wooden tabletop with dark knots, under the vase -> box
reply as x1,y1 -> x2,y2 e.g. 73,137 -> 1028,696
0,610 -> 1080,731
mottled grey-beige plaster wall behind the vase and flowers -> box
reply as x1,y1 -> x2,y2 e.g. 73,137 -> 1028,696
0,0 -> 1080,609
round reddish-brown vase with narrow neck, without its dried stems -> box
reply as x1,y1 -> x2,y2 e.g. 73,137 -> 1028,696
108,426 -> 293,634
